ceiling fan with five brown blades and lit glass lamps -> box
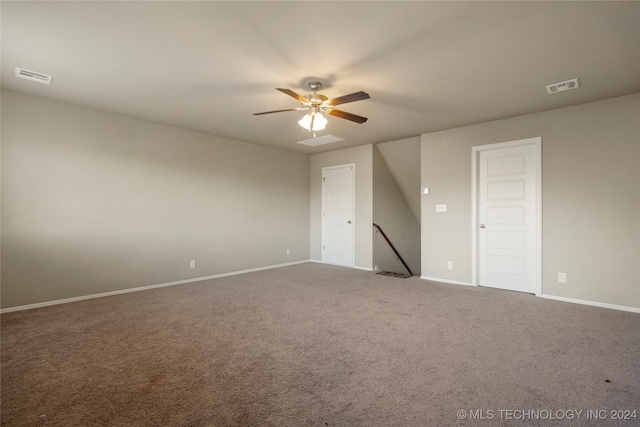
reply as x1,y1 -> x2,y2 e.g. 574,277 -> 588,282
253,82 -> 370,132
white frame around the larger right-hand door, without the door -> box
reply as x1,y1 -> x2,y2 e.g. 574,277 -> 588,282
471,136 -> 542,296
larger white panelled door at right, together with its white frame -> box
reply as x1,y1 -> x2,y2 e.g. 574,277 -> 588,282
474,138 -> 541,294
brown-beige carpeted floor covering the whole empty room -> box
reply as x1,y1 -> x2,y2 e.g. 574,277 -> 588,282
1,263 -> 640,427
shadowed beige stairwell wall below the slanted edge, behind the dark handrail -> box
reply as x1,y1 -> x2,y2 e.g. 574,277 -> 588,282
373,146 -> 420,276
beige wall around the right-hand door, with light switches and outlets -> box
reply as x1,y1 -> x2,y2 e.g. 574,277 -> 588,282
421,94 -> 640,308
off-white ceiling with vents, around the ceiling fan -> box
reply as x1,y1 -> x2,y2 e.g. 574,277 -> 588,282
1,1 -> 640,153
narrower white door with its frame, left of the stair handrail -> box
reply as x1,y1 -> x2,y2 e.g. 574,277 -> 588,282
322,165 -> 354,267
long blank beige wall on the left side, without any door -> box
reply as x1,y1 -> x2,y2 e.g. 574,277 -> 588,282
2,91 -> 310,308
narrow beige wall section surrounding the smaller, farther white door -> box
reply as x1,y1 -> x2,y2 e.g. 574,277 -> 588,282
310,145 -> 373,269
